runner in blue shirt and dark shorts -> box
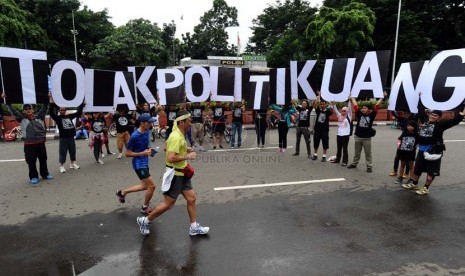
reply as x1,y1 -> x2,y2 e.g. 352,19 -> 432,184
116,114 -> 155,215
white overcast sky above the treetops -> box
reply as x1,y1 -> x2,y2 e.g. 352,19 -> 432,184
81,0 -> 322,51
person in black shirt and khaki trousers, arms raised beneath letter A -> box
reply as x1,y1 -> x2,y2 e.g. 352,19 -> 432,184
347,95 -> 386,173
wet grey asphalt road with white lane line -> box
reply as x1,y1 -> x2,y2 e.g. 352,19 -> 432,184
0,126 -> 465,276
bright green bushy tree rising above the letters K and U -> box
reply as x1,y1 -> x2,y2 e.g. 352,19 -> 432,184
307,2 -> 376,59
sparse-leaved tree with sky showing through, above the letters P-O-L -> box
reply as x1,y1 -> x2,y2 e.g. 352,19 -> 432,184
185,0 -> 239,59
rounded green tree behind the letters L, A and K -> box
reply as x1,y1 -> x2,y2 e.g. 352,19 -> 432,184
90,18 -> 170,70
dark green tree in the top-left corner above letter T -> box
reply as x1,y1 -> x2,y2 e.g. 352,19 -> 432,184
0,0 -> 47,49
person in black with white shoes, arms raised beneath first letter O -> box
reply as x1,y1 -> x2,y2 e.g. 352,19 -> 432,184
50,101 -> 84,173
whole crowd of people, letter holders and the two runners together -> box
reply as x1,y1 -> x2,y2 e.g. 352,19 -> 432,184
2,93 -> 465,235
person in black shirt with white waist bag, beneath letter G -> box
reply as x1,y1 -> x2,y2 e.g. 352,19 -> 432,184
402,108 -> 465,195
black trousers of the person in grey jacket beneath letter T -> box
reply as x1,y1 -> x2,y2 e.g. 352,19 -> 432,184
24,143 -> 48,179
